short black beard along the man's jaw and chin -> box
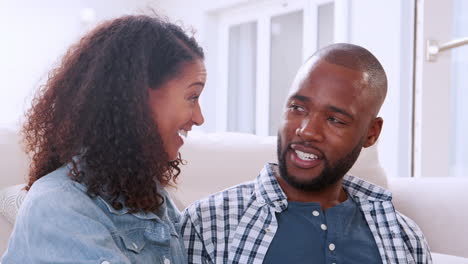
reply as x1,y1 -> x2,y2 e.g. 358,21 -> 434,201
277,134 -> 363,192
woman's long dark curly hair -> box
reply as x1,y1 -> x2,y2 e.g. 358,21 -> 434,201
22,15 -> 204,212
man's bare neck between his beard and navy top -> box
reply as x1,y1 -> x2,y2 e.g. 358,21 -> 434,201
276,176 -> 348,211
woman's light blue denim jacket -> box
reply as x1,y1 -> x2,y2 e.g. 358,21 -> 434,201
2,166 -> 187,264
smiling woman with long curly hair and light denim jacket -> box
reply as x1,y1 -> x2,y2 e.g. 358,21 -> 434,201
2,15 -> 206,264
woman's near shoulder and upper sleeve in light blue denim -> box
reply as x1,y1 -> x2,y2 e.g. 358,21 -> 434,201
4,167 -> 129,263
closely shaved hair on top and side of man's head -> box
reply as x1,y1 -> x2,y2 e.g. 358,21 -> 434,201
303,43 -> 387,115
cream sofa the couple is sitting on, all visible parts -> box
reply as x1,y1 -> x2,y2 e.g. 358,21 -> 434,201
0,127 -> 468,264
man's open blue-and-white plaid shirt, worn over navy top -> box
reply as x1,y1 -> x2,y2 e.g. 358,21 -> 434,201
182,164 -> 432,264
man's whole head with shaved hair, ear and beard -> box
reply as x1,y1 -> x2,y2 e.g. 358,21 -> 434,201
278,44 -> 387,195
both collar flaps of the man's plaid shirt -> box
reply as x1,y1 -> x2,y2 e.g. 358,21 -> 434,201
255,163 -> 392,212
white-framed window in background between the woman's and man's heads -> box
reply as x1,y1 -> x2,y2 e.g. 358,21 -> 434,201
216,0 -> 336,135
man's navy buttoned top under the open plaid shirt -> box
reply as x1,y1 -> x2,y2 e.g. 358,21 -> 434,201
263,193 -> 382,264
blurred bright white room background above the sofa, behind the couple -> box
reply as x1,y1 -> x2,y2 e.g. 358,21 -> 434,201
0,0 -> 468,177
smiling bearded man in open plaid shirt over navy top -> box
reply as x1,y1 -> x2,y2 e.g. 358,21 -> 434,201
182,44 -> 431,264
